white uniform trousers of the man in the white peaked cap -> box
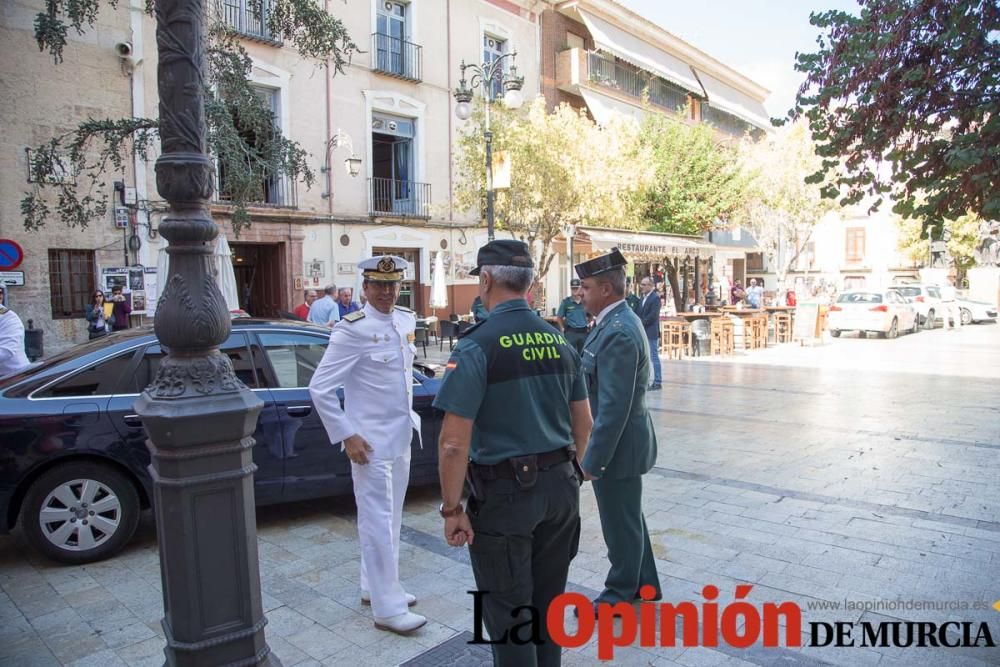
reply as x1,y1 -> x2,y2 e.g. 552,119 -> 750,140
351,449 -> 410,618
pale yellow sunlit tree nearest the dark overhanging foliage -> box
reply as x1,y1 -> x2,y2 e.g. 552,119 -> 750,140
734,122 -> 836,287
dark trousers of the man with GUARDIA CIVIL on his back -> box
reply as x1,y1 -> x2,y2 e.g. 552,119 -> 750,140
469,462 -> 580,667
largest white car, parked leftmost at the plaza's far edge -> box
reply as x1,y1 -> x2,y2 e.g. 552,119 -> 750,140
827,288 -> 918,338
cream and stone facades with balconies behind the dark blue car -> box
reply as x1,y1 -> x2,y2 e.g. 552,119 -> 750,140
0,0 -> 547,352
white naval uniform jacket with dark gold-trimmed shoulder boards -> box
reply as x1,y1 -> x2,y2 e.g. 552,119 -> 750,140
309,304 -> 420,458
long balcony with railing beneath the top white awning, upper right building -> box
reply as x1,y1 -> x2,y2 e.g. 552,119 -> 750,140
556,48 -> 688,112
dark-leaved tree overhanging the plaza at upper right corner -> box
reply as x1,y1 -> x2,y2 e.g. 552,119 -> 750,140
789,0 -> 1000,230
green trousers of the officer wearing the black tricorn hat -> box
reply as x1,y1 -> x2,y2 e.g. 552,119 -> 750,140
593,477 -> 660,603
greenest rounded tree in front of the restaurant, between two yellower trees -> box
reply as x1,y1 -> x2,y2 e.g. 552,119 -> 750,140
639,113 -> 749,310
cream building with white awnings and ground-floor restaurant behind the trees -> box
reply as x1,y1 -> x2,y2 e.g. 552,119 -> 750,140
540,0 -> 771,307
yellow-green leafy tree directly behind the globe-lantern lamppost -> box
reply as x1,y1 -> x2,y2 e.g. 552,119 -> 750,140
455,96 -> 652,300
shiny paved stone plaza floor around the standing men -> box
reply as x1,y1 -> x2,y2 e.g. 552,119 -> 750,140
0,325 -> 1000,667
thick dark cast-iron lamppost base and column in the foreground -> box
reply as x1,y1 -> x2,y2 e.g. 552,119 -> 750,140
135,0 -> 281,667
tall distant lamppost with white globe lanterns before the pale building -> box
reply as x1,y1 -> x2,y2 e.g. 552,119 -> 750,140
455,51 -> 524,241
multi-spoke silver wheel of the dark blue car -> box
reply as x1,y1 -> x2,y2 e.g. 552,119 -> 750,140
21,462 -> 140,565
